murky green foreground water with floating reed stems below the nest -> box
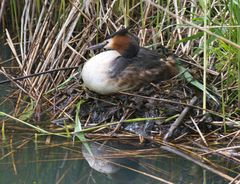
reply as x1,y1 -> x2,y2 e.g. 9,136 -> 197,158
0,136 -> 227,184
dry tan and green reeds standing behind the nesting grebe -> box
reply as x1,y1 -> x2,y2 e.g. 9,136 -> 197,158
1,0 -> 240,114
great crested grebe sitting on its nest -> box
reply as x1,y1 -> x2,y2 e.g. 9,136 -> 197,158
82,29 -> 178,94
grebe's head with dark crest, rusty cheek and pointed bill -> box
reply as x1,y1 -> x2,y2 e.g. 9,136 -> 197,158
89,28 -> 139,58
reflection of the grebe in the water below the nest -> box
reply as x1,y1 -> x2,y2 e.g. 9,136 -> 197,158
82,142 -> 140,183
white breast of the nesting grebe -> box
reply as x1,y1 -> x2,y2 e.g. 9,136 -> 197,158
82,50 -> 120,94
